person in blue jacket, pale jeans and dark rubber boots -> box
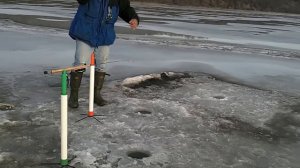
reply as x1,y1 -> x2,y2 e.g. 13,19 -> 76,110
68,0 -> 139,108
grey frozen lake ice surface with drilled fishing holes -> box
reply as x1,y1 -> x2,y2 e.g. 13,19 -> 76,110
0,0 -> 300,168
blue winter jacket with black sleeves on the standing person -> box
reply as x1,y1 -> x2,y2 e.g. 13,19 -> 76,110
69,0 -> 139,47
